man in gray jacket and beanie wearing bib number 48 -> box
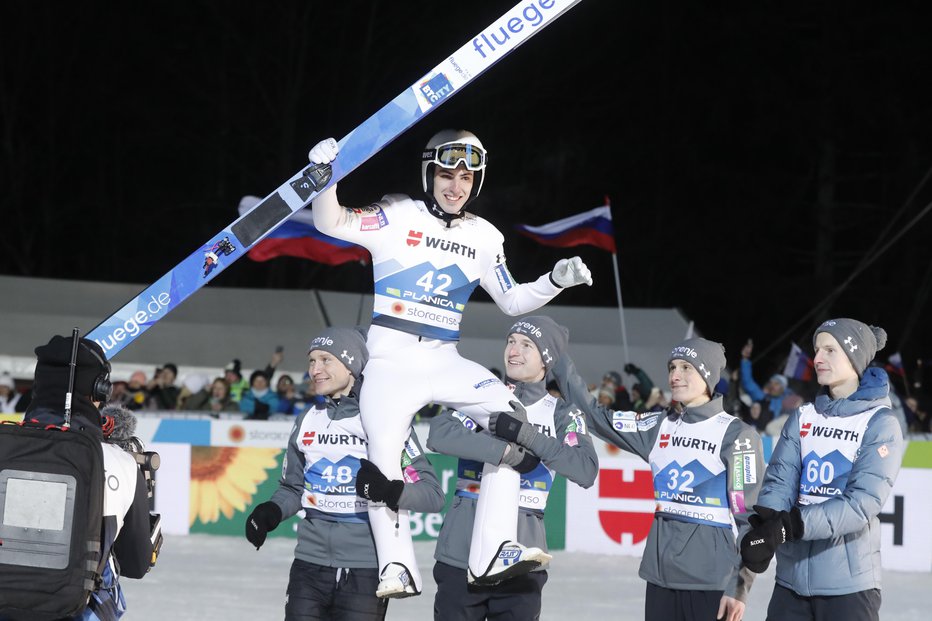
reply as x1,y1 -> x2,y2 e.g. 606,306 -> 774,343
246,328 -> 444,621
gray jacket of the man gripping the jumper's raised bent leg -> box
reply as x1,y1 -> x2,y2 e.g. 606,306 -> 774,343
427,382 -> 599,569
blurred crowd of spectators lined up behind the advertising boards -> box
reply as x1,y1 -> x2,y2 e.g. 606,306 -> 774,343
0,340 -> 932,437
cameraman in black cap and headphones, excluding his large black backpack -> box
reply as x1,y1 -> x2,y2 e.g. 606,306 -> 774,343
24,336 -> 154,621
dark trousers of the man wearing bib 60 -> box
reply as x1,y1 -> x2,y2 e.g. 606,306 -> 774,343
767,584 -> 880,621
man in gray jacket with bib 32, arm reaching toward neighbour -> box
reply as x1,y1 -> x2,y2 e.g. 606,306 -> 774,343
553,338 -> 764,621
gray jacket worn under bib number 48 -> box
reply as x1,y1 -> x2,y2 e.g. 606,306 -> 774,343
271,383 -> 444,569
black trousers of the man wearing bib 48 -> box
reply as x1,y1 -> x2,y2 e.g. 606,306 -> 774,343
285,559 -> 388,621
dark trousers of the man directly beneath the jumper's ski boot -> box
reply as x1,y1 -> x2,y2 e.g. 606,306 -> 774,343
434,563 -> 547,621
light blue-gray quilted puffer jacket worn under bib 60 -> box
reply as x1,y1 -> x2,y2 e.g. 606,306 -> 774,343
758,368 -> 905,597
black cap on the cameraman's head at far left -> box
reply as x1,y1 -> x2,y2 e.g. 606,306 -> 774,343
26,336 -> 110,425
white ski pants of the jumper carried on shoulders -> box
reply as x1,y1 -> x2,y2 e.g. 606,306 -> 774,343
359,326 -> 521,590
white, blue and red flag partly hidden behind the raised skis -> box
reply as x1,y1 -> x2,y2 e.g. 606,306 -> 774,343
239,196 -> 369,265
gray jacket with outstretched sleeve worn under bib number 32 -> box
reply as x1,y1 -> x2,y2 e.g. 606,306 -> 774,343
551,355 -> 764,601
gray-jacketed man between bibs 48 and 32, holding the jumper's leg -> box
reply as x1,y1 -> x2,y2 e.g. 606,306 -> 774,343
427,316 -> 599,621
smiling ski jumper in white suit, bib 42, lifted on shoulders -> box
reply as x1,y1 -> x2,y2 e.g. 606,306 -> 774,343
309,131 -> 592,596
